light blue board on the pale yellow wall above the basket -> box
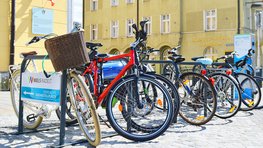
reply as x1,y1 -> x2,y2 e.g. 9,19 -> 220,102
32,8 -> 54,34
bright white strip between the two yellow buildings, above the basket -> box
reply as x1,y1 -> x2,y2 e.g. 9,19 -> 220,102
68,0 -> 84,32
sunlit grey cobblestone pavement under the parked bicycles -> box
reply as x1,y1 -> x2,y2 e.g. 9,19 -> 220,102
0,91 -> 263,148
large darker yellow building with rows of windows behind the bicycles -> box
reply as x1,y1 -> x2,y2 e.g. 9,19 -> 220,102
85,0 -> 263,65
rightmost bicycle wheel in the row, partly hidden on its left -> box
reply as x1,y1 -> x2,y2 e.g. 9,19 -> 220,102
235,73 -> 261,111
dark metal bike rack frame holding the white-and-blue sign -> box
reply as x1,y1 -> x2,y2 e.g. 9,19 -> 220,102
18,55 -> 67,145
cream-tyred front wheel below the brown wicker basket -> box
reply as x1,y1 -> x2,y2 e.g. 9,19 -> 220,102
67,71 -> 101,146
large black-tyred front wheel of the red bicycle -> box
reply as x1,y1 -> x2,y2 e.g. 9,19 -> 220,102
106,75 -> 173,141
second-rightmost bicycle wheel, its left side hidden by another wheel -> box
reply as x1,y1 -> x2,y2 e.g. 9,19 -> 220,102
209,73 -> 241,119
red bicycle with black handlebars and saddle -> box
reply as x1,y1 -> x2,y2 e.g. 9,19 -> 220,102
82,21 -> 174,141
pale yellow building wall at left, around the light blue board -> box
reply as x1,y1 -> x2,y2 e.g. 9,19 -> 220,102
0,0 -> 67,72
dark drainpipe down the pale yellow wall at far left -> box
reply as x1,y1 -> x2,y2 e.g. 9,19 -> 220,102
9,0 -> 16,65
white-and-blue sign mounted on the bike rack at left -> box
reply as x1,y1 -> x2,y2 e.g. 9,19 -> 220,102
21,71 -> 61,105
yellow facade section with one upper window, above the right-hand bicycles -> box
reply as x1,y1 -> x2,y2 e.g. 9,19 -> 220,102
181,0 -> 238,60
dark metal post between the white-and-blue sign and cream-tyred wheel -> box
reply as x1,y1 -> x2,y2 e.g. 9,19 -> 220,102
59,70 -> 67,145
